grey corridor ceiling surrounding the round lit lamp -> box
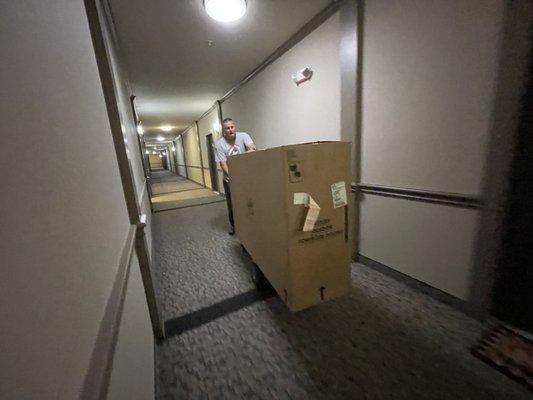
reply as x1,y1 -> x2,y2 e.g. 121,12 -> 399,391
109,0 -> 330,140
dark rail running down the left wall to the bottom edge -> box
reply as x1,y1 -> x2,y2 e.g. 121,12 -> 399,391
80,225 -> 137,400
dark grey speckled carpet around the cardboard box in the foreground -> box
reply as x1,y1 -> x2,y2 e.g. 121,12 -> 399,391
153,203 -> 531,399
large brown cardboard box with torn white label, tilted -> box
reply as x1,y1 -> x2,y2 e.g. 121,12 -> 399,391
228,142 -> 351,311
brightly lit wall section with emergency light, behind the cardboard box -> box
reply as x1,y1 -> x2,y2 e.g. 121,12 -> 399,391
222,12 -> 341,149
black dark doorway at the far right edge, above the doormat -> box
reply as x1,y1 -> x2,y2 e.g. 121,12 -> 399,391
492,44 -> 533,332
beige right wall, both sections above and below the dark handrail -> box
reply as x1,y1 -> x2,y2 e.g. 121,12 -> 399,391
360,0 -> 503,299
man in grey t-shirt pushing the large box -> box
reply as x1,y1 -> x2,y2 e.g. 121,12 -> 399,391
215,118 -> 256,235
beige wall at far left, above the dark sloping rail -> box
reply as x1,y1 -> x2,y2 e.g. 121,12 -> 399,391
0,0 -> 153,399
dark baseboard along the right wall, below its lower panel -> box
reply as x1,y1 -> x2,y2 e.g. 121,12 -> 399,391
354,253 -> 490,321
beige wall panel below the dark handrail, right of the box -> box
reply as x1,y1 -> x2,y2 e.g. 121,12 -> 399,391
360,194 -> 478,300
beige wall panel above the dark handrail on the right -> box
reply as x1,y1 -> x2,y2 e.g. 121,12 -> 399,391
361,0 -> 503,194
